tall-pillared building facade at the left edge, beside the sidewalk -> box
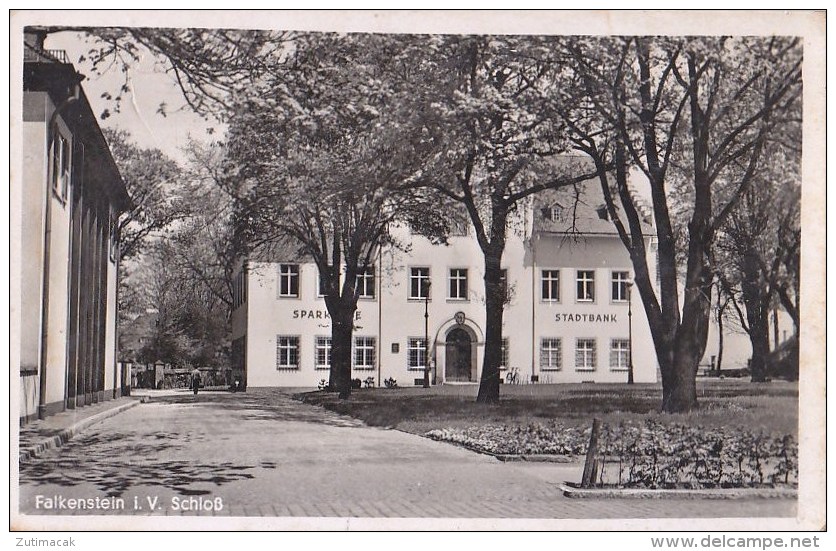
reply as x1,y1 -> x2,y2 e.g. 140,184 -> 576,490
19,31 -> 130,423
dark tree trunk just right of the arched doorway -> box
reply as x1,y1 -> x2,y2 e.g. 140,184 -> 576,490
476,250 -> 507,404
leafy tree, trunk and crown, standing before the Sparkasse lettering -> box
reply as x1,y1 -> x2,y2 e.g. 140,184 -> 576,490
220,34 -> 446,395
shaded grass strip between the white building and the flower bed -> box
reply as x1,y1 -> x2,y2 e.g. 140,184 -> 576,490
297,379 -> 798,437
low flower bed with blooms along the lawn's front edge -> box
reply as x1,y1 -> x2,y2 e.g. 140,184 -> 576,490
425,420 -> 798,489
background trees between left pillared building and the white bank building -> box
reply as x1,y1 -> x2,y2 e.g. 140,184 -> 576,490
120,140 -> 236,367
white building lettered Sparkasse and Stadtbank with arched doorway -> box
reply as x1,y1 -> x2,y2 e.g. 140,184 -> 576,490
233,183 -> 657,387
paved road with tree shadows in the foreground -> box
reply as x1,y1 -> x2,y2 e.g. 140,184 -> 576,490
20,391 -> 796,519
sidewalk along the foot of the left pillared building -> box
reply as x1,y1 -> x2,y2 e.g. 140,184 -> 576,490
18,396 -> 141,463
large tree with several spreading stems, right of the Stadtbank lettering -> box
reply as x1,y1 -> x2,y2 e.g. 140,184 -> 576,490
558,37 -> 801,411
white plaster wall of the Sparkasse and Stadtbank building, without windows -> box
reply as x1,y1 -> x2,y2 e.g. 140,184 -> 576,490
242,222 -> 657,386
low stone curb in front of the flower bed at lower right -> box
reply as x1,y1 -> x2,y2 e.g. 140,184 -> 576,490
557,483 -> 798,499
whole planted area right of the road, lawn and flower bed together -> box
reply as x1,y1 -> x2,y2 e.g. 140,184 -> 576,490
297,379 -> 798,489
